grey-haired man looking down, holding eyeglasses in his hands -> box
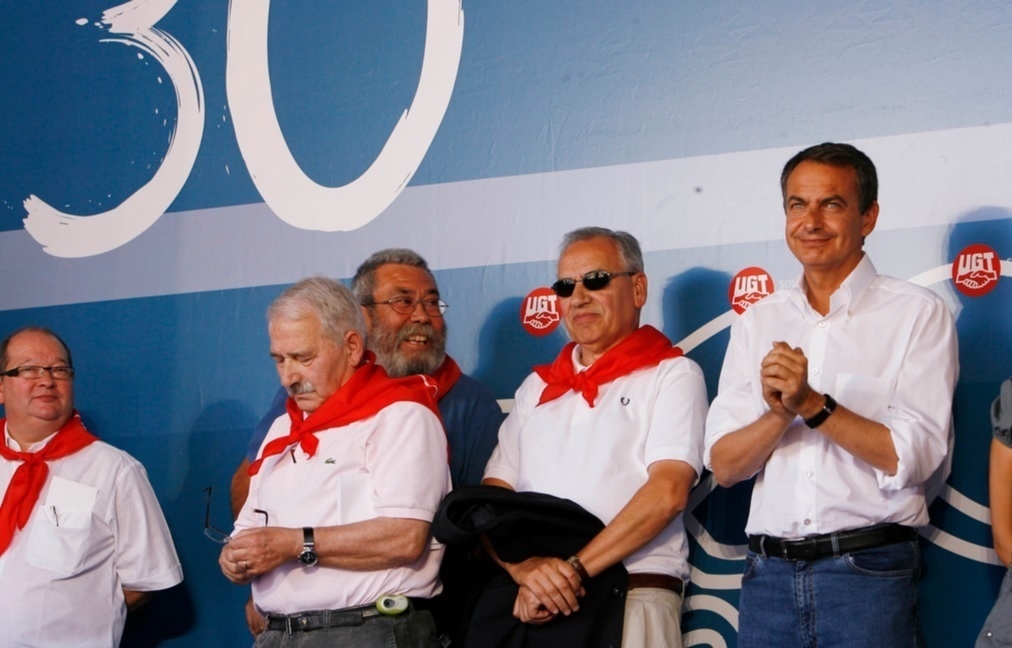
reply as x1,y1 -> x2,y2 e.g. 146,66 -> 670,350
219,277 -> 449,648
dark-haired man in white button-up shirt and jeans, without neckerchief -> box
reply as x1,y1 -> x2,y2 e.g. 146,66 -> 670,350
706,143 -> 958,648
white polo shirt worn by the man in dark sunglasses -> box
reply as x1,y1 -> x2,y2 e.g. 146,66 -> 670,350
485,346 -> 706,578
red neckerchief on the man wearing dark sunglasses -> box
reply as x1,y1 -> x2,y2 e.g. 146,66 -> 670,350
534,326 -> 682,407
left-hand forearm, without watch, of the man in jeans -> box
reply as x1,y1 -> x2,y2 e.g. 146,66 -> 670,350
710,409 -> 794,488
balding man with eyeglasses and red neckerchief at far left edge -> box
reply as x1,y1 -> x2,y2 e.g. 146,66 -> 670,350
0,326 -> 183,648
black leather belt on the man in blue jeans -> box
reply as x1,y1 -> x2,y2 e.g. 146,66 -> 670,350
749,524 -> 917,560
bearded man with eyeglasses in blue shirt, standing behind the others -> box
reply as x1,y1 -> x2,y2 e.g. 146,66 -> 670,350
232,248 -> 503,635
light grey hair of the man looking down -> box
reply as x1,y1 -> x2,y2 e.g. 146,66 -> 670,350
267,276 -> 365,346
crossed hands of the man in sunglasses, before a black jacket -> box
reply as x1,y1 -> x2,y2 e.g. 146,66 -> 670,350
507,556 -> 586,625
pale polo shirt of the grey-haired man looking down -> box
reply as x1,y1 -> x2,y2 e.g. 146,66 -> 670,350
236,401 -> 449,614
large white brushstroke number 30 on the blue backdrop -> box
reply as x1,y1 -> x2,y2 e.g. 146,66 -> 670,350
24,0 -> 463,257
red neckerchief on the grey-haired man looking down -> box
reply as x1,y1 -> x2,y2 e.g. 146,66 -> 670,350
249,351 -> 439,477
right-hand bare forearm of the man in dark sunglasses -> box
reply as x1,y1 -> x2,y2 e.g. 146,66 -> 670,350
577,461 -> 696,577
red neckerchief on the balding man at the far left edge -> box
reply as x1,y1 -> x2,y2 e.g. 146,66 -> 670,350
0,411 -> 98,555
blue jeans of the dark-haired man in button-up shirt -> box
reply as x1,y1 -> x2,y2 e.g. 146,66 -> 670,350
738,542 -> 923,648
